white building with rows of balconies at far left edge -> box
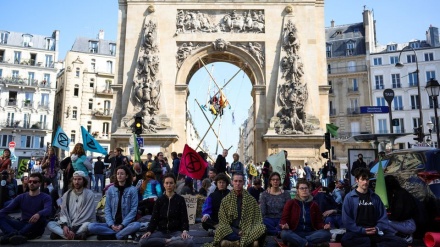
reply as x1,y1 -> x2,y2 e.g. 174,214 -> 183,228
0,30 -> 59,167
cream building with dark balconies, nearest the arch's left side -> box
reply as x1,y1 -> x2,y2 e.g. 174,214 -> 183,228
53,31 -> 116,157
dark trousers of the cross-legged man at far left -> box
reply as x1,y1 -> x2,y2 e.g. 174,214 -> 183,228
0,216 -> 47,239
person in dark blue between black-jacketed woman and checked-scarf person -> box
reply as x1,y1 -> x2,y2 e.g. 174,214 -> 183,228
201,173 -> 230,235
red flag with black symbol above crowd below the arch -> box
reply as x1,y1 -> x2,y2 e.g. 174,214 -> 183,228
179,144 -> 208,180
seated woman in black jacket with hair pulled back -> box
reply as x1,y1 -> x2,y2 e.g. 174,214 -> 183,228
139,174 -> 194,247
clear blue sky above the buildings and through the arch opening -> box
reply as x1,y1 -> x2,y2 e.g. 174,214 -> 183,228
0,0 -> 440,156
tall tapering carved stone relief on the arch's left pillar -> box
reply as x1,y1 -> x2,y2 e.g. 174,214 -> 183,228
131,20 -> 162,133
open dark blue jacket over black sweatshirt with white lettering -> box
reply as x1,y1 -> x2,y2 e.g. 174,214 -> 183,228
342,189 -> 390,234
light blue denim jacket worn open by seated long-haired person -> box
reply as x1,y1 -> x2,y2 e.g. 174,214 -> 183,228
104,186 -> 138,227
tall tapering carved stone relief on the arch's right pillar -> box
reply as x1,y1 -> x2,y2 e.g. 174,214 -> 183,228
274,20 -> 317,135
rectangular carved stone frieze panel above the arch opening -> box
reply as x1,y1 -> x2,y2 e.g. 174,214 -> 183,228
175,9 -> 265,35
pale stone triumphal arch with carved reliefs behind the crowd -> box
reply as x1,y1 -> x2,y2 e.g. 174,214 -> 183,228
112,0 -> 329,165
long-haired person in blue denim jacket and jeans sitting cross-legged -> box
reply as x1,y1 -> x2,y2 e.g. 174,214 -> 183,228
88,165 -> 141,240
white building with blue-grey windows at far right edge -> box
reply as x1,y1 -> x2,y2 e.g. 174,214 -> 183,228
370,26 -> 440,148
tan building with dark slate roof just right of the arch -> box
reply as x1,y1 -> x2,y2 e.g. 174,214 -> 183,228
325,10 -> 376,175
